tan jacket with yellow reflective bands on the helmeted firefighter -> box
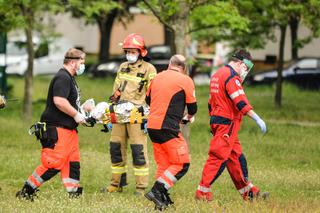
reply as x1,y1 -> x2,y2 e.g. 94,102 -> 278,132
113,60 -> 157,106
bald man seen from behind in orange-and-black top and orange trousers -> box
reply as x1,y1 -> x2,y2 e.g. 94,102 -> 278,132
145,55 -> 197,210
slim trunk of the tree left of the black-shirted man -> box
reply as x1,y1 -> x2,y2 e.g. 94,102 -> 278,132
23,25 -> 34,121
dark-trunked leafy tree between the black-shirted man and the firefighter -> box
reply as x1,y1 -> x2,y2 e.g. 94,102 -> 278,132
68,0 -> 137,62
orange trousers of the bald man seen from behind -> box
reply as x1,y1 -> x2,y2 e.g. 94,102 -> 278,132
149,130 -> 190,189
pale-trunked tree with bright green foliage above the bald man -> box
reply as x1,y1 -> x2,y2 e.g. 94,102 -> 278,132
143,0 -> 248,54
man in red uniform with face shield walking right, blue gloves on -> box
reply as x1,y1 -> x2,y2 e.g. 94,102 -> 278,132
195,50 -> 267,201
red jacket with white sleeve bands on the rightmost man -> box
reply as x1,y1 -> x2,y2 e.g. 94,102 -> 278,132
208,65 -> 252,123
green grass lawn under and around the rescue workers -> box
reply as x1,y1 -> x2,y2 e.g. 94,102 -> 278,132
0,76 -> 320,212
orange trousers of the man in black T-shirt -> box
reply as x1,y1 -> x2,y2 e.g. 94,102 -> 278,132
27,128 -> 80,192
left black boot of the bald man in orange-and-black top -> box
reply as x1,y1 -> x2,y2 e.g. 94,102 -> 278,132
144,181 -> 168,211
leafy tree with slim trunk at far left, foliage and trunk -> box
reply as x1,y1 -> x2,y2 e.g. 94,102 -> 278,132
0,0 -> 63,120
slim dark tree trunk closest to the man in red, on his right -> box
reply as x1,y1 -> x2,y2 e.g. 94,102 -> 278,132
275,25 -> 287,108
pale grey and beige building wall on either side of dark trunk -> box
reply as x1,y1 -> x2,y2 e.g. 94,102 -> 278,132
54,14 -> 164,54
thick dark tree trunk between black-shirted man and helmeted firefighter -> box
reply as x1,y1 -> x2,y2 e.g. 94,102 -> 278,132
97,9 -> 118,63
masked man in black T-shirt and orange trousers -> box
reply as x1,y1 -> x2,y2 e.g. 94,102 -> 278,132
16,48 -> 85,200
